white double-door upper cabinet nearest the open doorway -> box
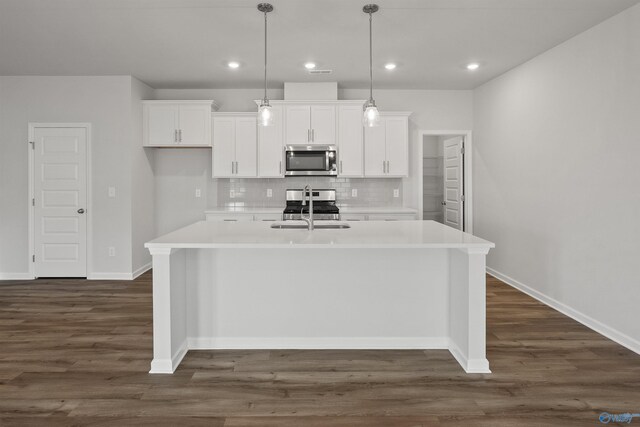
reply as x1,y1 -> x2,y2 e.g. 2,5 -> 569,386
364,113 -> 410,177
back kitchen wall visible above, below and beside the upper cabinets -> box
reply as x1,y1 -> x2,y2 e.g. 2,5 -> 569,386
155,89 -> 473,234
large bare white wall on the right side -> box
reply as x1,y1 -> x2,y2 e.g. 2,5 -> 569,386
473,6 -> 640,351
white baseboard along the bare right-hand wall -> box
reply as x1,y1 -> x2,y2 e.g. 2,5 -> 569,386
487,267 -> 640,354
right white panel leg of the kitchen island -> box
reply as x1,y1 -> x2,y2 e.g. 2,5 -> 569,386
449,249 -> 491,373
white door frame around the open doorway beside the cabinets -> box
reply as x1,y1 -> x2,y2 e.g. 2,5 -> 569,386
418,130 -> 473,234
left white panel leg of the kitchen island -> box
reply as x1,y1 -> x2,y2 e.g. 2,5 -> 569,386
149,248 -> 187,374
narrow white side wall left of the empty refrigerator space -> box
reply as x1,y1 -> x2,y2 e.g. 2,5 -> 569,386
130,77 -> 156,272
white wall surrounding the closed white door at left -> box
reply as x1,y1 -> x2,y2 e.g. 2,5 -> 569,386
0,76 -> 131,277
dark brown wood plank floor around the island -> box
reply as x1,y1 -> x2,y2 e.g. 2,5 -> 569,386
0,273 -> 640,427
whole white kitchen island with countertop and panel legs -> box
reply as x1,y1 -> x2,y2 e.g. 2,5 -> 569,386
145,221 -> 494,373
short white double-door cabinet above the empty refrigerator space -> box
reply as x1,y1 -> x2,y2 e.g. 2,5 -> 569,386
143,100 -> 215,147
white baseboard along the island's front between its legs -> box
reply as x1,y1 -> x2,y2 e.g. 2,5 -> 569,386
188,337 -> 449,350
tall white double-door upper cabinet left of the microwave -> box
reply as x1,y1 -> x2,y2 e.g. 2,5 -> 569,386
211,113 -> 258,178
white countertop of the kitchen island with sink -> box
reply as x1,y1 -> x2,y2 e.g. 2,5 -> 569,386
145,221 -> 495,251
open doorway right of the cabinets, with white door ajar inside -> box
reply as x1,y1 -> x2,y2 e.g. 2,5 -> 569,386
420,131 -> 472,232
